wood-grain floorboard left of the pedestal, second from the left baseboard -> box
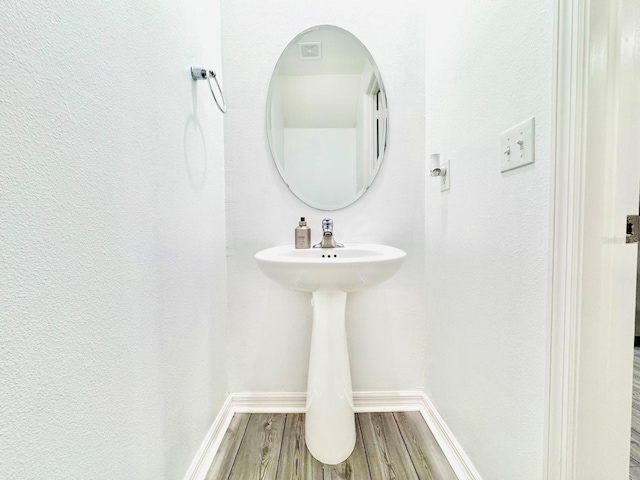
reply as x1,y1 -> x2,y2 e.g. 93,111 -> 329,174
229,413 -> 286,480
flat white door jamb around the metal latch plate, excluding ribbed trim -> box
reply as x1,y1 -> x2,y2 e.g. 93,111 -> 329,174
575,0 -> 640,480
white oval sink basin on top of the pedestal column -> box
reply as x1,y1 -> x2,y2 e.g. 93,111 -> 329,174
256,243 -> 406,292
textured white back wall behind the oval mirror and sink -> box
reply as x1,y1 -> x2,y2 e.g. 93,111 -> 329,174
221,0 -> 425,391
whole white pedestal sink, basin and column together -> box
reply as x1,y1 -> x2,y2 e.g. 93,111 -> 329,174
255,244 -> 406,465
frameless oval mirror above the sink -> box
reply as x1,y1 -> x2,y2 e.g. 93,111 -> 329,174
266,25 -> 388,210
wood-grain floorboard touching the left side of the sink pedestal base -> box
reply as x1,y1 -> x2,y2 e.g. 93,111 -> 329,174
276,413 -> 324,480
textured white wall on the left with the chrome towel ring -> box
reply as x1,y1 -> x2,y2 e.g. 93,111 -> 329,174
0,0 -> 226,480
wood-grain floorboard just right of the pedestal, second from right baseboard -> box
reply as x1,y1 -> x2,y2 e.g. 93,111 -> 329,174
359,413 -> 419,480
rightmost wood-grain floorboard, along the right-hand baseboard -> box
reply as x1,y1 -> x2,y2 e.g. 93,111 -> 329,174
393,412 -> 458,480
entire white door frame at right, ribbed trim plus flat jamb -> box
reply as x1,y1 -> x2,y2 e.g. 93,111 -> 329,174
546,0 -> 640,480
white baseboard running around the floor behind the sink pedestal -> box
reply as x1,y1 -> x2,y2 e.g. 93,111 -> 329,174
184,391 -> 482,480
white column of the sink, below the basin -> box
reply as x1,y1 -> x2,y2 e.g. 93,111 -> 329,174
305,291 -> 356,465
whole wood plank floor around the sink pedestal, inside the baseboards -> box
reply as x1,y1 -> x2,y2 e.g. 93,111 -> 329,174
206,412 -> 457,480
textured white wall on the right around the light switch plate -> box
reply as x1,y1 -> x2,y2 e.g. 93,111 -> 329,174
424,0 -> 554,480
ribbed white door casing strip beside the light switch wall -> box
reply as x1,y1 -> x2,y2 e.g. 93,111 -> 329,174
543,0 -> 589,480
